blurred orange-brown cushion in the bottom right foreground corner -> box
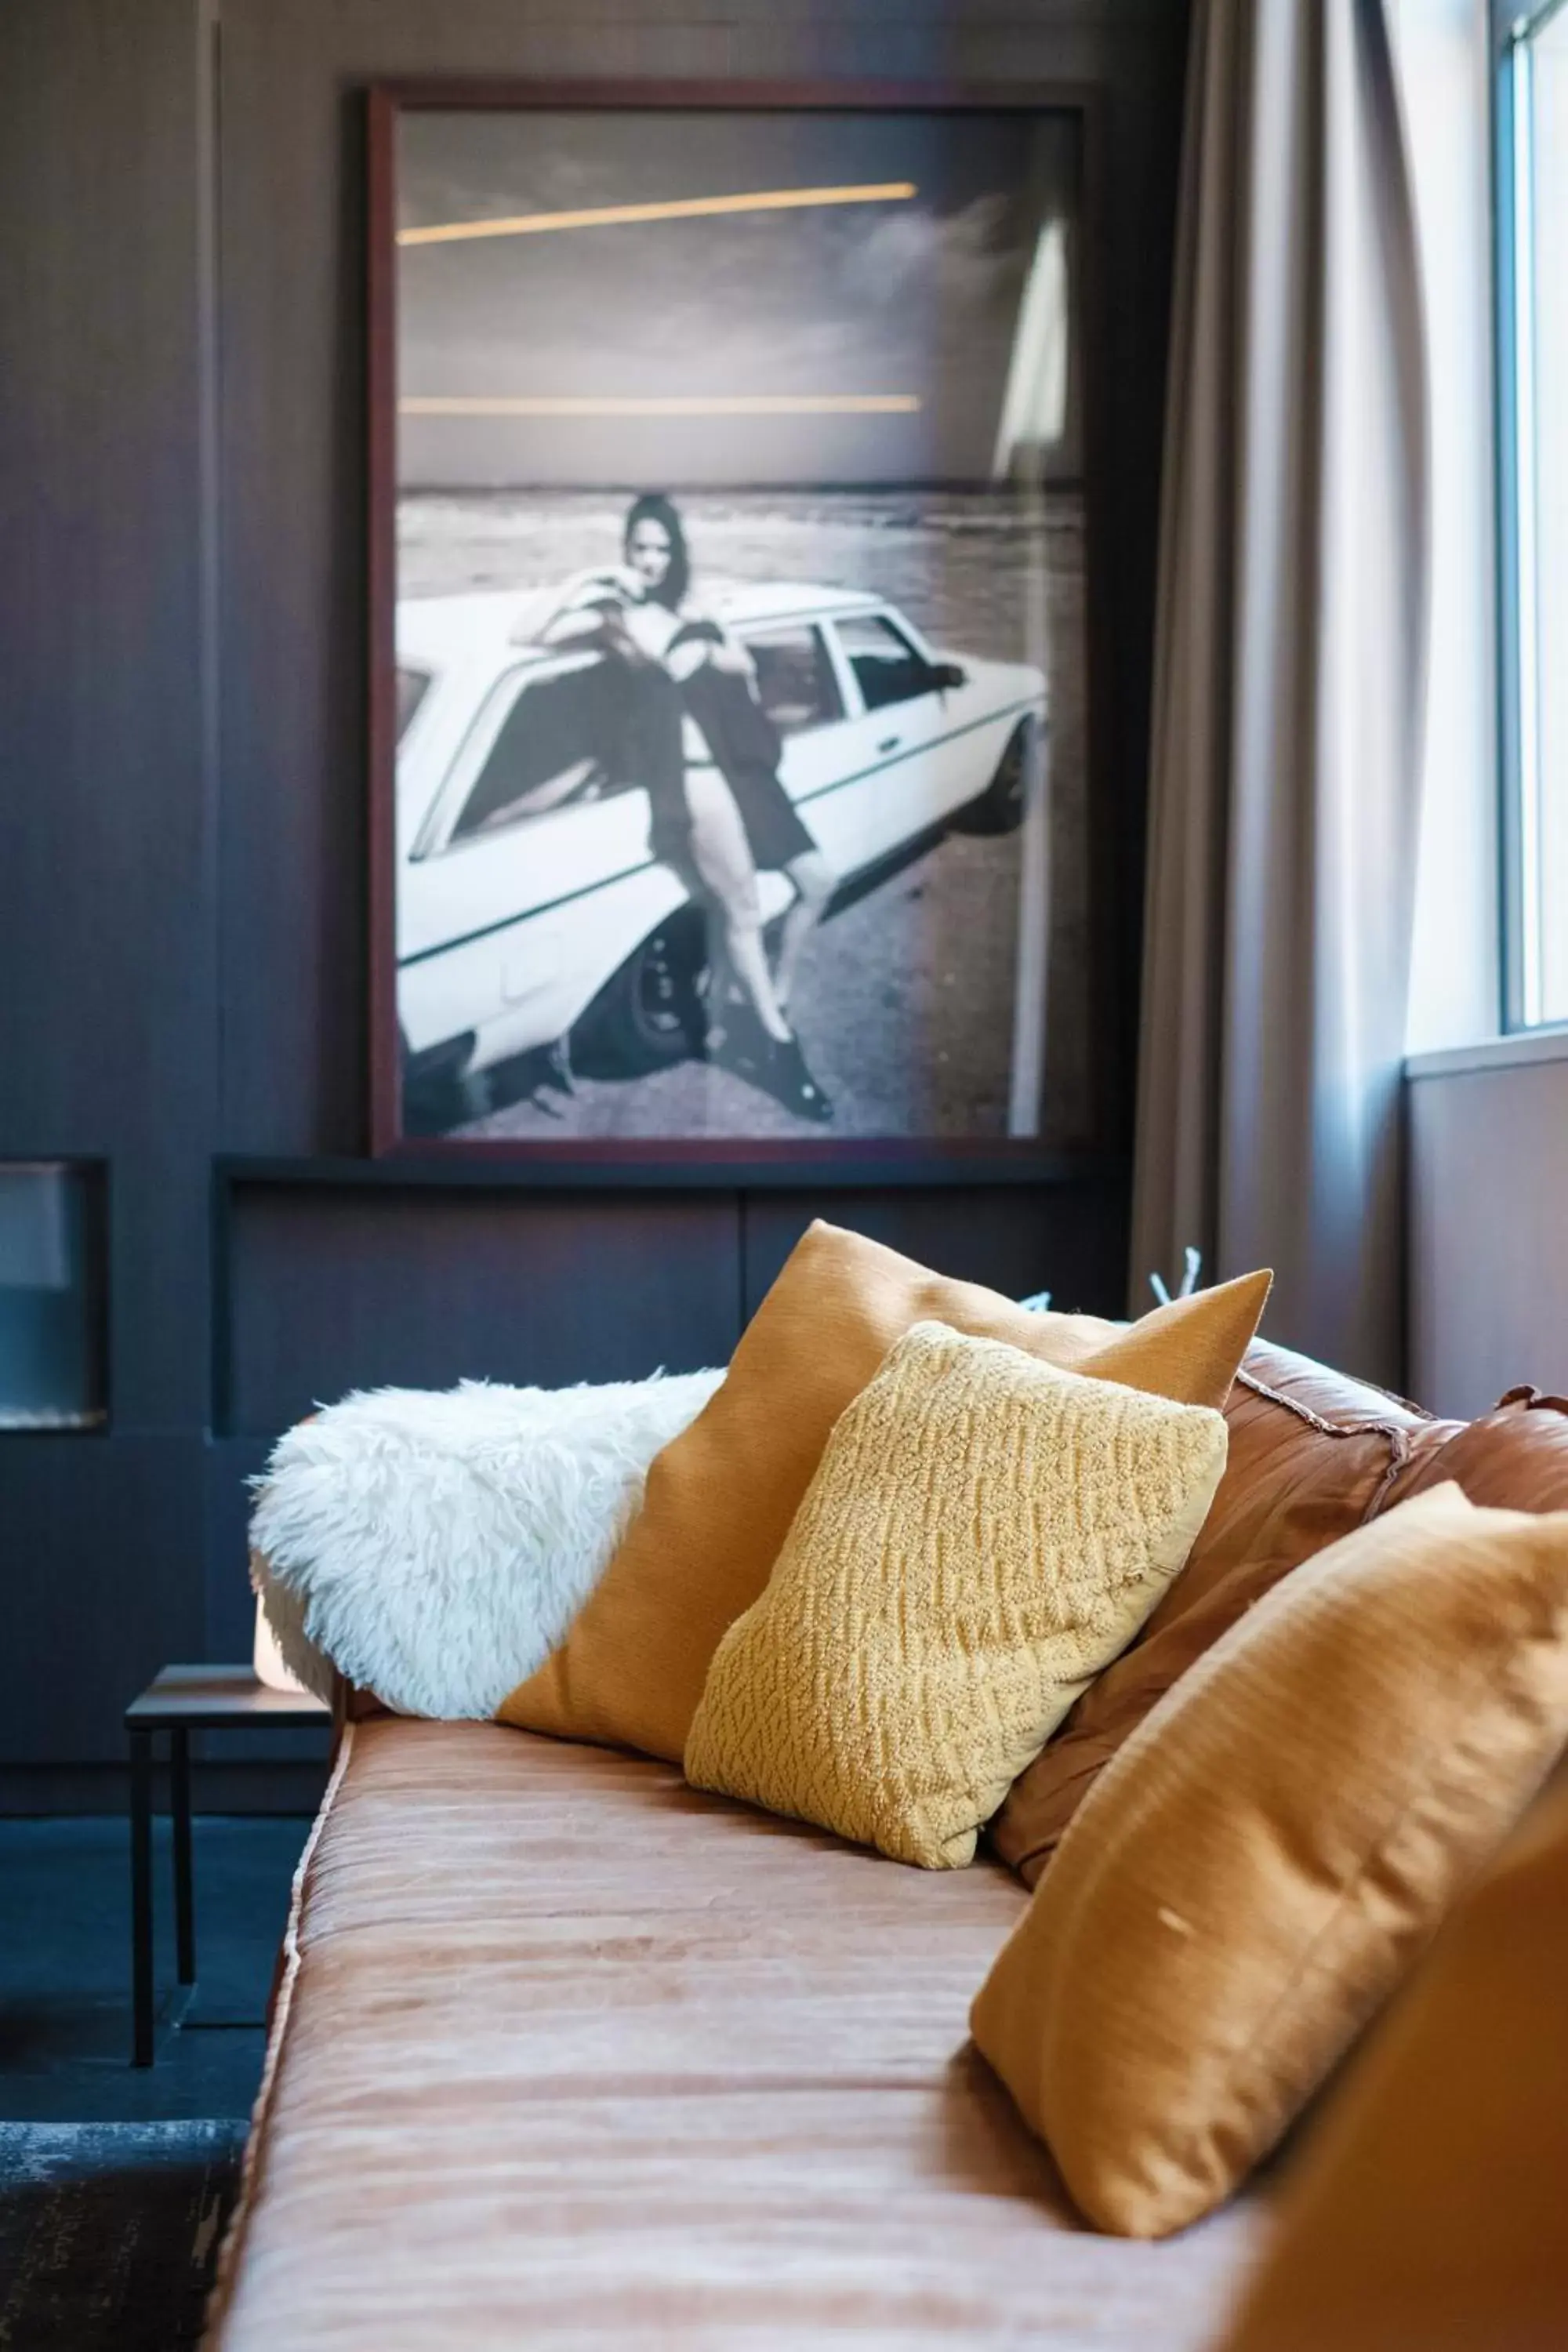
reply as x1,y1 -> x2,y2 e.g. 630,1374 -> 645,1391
1225,1780 -> 1568,2352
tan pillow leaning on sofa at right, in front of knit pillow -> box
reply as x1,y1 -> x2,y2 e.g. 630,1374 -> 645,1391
971,1484 -> 1568,2237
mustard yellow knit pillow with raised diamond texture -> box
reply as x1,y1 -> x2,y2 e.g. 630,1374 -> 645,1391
687,1322 -> 1225,1870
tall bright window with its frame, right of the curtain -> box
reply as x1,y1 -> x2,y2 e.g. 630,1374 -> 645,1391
1497,0 -> 1568,1028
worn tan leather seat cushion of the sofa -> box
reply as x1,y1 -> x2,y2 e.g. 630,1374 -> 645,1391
207,1722 -> 1255,2352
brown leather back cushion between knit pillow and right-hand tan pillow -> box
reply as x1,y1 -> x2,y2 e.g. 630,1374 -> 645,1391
987,1341 -> 1439,1886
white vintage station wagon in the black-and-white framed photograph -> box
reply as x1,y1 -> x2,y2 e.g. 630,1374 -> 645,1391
397,586 -> 1046,1124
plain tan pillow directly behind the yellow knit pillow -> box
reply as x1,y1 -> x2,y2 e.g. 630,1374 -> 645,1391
496,1221 -> 1269,1762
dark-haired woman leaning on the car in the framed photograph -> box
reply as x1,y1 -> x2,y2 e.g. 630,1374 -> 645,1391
548,494 -> 832,1122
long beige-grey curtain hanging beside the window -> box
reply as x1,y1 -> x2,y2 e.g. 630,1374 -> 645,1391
1133,0 -> 1427,1383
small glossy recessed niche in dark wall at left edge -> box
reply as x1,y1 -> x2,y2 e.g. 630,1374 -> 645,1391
0,1160 -> 108,1435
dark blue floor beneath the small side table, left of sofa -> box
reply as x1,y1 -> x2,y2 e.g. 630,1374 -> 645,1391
0,1816 -> 310,2124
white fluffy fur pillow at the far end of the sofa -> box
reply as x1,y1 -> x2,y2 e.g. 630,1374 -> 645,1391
252,1371 -> 724,1719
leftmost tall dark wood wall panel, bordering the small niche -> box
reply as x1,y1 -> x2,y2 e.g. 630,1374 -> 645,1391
0,0 -> 216,1430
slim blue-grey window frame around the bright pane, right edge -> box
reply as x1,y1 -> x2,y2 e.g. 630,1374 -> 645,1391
1490,0 -> 1568,1035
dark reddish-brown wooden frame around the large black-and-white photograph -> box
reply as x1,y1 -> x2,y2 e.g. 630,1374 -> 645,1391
367,80 -> 1121,1183
